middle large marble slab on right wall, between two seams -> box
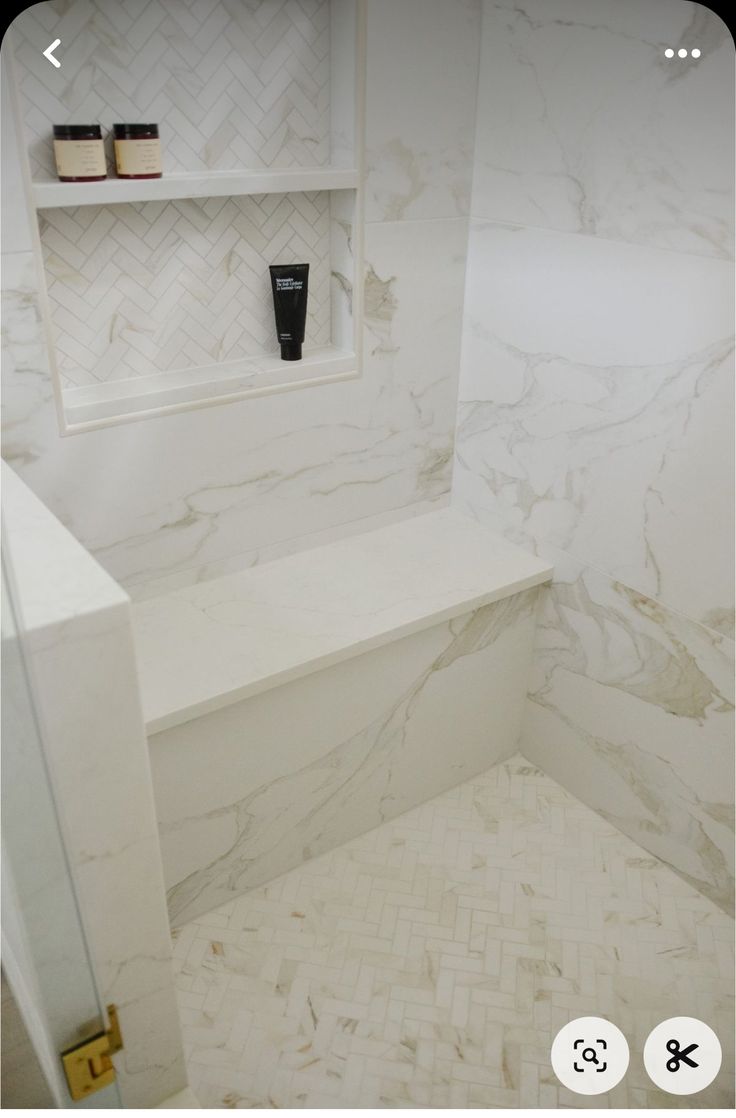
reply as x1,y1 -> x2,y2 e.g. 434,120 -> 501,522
455,222 -> 734,635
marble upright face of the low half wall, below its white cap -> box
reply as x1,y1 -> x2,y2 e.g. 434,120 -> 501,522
26,606 -> 187,1107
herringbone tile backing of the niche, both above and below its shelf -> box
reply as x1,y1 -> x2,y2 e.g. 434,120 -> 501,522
15,0 -> 330,387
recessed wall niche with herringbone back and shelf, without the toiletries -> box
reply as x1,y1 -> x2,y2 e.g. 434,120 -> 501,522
5,0 -> 365,434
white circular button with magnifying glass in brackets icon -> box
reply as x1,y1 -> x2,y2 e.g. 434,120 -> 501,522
551,1017 -> 629,1095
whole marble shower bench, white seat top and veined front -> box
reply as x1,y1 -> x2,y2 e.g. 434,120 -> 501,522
133,509 -> 551,925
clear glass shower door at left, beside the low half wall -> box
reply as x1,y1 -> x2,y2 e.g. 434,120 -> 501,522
1,543 -> 122,1109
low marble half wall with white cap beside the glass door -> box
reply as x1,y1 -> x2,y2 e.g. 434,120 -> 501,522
2,467 -> 187,1108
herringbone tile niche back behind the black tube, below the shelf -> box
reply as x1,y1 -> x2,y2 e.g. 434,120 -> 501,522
40,192 -> 330,387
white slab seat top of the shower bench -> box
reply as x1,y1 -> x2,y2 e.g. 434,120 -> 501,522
133,509 -> 551,732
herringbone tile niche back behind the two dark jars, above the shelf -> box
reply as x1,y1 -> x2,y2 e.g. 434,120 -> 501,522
13,0 -> 330,179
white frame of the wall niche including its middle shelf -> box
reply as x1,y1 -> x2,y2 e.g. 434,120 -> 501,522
3,0 -> 366,436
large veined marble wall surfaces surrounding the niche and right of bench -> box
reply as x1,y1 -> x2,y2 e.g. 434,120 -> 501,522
2,0 -> 734,903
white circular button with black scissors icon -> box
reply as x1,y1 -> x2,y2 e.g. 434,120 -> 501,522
644,1017 -> 721,1095
